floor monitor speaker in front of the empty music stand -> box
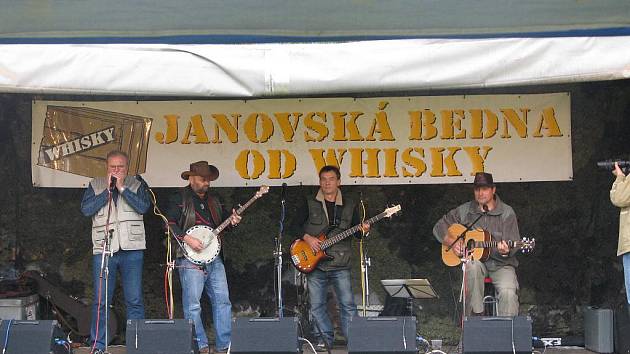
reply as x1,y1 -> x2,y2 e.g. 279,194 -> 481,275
348,316 -> 418,354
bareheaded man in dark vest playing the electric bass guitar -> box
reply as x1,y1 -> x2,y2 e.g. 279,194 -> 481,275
294,166 -> 370,351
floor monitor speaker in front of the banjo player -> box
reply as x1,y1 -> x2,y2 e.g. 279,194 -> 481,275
125,319 -> 198,354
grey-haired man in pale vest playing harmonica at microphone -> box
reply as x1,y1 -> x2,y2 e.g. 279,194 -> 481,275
81,151 -> 151,353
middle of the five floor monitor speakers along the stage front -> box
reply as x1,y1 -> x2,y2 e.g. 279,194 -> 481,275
230,317 -> 299,354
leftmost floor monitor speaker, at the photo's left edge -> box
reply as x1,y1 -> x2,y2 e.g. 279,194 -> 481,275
0,320 -> 67,354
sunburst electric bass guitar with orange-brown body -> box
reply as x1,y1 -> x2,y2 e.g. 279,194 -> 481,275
289,204 -> 400,273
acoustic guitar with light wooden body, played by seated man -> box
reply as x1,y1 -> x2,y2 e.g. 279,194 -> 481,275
442,224 -> 536,267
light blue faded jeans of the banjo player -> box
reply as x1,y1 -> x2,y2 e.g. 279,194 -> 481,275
177,257 -> 232,349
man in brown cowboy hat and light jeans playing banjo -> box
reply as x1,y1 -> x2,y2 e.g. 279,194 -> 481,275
167,161 -> 241,353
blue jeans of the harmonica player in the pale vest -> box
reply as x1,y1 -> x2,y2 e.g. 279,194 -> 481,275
90,250 -> 144,350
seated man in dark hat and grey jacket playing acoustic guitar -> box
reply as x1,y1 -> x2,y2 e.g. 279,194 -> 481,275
433,172 -> 521,316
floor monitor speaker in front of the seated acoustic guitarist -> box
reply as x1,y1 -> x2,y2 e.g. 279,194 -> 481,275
463,316 -> 532,354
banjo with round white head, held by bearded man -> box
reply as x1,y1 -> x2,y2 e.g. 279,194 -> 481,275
182,186 -> 269,265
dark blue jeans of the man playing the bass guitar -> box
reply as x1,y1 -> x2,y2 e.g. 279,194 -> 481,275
306,269 -> 357,344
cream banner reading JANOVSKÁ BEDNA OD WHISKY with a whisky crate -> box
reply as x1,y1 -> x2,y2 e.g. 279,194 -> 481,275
32,93 -> 573,187
